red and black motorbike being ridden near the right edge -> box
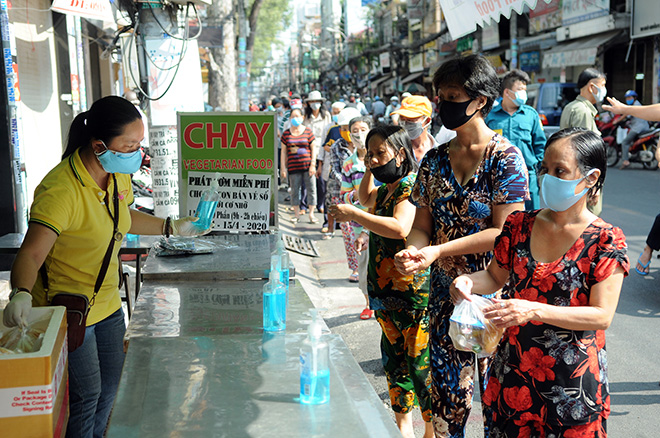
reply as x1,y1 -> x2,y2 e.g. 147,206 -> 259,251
601,116 -> 660,170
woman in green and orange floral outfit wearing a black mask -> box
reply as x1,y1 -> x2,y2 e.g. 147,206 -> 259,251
331,125 -> 433,438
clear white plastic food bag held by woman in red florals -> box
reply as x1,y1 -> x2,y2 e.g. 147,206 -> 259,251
449,295 -> 504,357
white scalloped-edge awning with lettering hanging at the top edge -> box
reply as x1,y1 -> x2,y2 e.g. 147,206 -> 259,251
440,0 -> 551,40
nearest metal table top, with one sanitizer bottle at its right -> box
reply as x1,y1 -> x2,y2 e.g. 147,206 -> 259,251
106,334 -> 401,438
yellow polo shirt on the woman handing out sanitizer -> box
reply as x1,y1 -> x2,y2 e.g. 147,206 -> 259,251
30,151 -> 133,326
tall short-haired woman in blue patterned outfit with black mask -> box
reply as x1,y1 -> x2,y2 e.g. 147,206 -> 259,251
396,55 -> 529,438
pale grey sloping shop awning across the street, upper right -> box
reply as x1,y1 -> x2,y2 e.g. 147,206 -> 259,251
543,30 -> 621,68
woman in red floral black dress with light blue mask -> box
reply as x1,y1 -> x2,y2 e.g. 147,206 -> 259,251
450,128 -> 630,438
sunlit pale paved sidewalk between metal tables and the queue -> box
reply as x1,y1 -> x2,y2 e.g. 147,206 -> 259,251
279,191 -> 483,438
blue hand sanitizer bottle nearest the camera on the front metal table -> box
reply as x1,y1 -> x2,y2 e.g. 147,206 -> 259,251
300,309 -> 330,405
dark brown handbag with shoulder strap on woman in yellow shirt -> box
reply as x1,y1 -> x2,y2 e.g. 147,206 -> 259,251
39,175 -> 123,353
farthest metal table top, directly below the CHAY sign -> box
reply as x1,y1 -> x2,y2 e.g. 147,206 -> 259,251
142,234 -> 295,281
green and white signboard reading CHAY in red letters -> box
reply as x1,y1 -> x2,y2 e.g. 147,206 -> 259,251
178,112 -> 278,232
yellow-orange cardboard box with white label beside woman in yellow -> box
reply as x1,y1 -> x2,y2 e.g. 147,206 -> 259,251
0,307 -> 69,438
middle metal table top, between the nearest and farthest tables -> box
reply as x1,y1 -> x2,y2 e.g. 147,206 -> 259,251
126,278 -> 314,338
